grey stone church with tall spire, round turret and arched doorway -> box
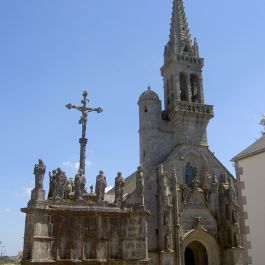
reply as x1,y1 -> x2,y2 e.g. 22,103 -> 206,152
138,0 -> 246,265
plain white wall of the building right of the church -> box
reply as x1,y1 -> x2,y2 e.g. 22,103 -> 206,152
238,152 -> 265,265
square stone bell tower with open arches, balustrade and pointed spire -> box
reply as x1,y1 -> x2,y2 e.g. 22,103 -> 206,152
161,0 -> 214,146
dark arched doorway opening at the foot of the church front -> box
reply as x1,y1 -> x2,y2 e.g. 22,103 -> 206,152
185,241 -> 208,265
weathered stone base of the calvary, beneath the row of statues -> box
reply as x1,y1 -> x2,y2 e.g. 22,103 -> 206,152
22,165 -> 149,265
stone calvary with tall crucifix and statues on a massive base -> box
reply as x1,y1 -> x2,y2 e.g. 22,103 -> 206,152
22,91 -> 149,265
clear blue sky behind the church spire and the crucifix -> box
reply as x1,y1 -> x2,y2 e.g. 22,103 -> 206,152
0,0 -> 265,255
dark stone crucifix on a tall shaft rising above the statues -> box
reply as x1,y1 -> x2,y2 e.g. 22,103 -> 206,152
65,91 -> 103,175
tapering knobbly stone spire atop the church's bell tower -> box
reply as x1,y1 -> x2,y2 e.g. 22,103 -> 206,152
170,0 -> 192,53
